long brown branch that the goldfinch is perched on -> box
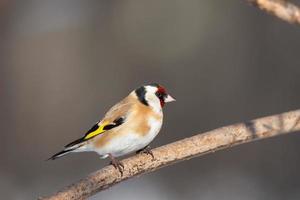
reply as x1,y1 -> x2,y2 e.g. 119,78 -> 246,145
40,110 -> 300,200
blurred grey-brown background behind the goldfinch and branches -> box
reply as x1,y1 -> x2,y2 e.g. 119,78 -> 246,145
0,0 -> 300,200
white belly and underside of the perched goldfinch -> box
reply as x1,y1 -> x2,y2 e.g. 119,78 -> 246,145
96,118 -> 162,158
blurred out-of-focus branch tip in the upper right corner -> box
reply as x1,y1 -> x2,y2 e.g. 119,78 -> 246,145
249,0 -> 300,24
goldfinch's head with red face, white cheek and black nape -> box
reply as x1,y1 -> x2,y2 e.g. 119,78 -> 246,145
135,83 -> 175,109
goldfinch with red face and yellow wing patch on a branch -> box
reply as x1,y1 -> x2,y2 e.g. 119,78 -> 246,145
49,83 -> 175,174
